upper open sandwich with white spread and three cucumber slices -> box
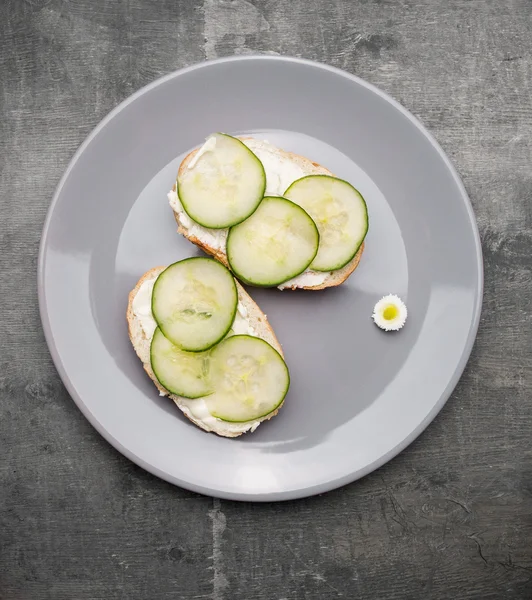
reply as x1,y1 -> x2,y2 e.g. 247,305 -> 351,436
168,133 -> 368,290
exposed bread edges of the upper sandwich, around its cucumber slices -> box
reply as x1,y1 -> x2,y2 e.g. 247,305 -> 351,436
172,137 -> 364,290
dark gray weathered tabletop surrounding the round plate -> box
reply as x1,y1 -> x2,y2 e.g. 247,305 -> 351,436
0,0 -> 532,600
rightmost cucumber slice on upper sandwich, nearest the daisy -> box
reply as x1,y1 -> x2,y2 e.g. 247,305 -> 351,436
284,175 -> 368,271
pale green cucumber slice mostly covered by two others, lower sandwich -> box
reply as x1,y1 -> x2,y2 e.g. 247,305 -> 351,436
150,327 -> 213,398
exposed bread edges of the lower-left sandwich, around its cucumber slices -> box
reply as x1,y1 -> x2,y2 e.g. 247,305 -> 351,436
127,267 -> 284,437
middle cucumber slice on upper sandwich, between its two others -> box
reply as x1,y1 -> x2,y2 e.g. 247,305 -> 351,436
226,196 -> 319,287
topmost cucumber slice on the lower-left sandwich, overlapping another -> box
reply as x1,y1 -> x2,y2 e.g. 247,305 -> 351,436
151,257 -> 238,352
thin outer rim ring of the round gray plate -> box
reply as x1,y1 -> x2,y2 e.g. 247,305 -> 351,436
37,54 -> 484,502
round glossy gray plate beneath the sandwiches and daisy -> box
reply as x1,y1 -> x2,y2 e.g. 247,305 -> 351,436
39,56 -> 482,500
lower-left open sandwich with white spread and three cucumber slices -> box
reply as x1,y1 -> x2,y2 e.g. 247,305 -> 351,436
127,257 -> 290,437
